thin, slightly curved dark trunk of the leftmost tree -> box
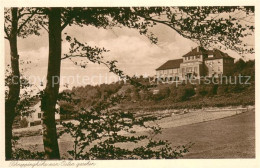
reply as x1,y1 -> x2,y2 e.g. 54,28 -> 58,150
5,8 -> 20,160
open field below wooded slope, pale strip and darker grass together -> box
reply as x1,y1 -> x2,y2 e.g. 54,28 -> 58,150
15,107 -> 255,159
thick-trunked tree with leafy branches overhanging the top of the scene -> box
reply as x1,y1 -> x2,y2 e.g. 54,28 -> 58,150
16,7 -> 254,159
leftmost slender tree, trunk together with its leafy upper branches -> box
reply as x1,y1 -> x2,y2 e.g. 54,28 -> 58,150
4,8 -> 40,160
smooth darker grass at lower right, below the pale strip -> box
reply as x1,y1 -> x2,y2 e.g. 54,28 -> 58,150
153,111 -> 255,159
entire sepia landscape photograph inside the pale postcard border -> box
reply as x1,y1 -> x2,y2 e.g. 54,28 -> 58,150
1,0 -> 256,167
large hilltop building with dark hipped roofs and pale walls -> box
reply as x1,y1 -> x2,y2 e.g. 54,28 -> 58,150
156,47 -> 234,81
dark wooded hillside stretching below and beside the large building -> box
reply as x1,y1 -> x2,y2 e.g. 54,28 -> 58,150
59,60 -> 255,112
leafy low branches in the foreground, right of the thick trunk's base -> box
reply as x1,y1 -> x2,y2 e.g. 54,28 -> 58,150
60,96 -> 191,159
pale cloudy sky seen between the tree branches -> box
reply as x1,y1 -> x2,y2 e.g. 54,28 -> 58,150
5,22 -> 254,88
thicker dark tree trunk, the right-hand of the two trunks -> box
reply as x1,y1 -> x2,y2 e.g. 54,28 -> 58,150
41,8 -> 62,159
